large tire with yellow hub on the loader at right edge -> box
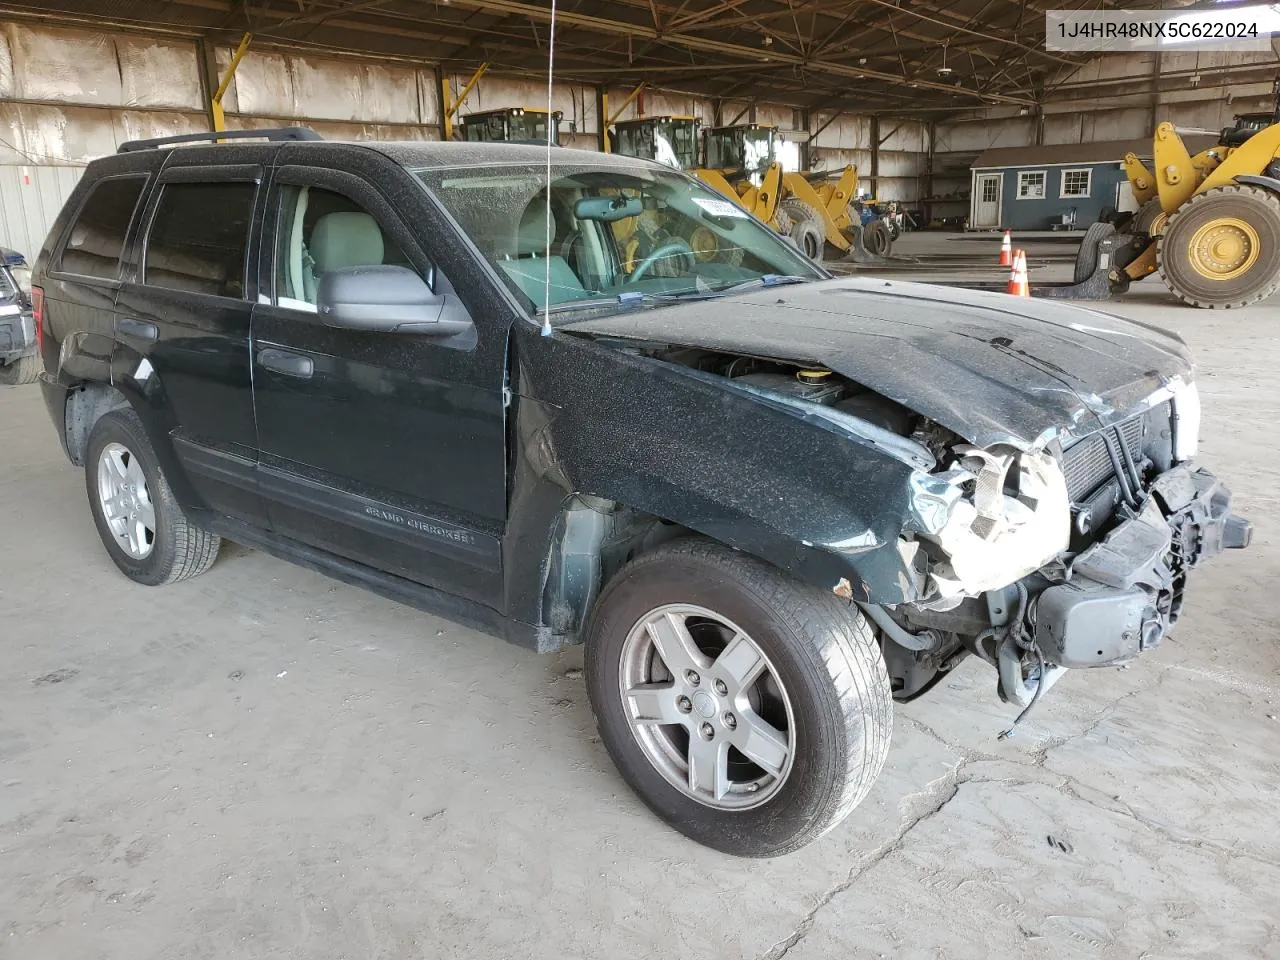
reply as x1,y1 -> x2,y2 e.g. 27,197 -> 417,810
1156,183 -> 1280,310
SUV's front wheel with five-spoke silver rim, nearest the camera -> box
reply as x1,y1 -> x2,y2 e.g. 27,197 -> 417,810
586,539 -> 892,856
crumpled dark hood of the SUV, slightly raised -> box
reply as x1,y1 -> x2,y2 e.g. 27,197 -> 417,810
559,278 -> 1192,448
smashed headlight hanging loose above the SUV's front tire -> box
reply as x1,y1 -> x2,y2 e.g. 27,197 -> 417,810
913,447 -> 1071,603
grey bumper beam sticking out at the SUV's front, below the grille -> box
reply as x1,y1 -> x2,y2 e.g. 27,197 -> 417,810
1033,466 -> 1253,667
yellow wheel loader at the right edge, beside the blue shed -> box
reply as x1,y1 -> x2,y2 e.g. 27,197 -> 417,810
1090,85 -> 1280,310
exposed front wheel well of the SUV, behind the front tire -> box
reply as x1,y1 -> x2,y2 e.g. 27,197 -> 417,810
543,494 -> 691,643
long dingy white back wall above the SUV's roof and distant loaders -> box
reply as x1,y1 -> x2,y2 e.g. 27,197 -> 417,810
0,22 -> 942,256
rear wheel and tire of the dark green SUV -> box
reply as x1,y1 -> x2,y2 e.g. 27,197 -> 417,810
84,410 -> 221,586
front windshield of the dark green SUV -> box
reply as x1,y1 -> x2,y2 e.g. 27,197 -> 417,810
417,165 -> 823,314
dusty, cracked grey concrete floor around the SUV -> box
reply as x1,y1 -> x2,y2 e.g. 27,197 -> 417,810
0,256 -> 1280,960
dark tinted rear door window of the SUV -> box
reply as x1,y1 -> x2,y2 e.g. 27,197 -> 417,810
142,183 -> 257,298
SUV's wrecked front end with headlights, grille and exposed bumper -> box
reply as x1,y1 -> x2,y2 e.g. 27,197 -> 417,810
863,384 -> 1252,707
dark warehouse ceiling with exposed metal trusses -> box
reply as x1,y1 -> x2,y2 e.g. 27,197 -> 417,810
0,0 -> 1155,113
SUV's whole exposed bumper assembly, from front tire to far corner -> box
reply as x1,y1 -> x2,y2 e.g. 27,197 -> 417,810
885,465 -> 1253,707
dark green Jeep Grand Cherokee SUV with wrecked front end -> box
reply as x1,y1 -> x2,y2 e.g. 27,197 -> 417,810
33,129 -> 1249,856
